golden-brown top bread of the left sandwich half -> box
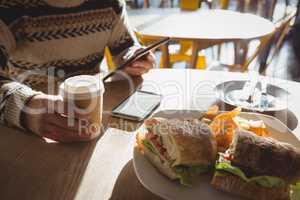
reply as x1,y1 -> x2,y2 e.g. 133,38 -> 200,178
148,118 -> 217,166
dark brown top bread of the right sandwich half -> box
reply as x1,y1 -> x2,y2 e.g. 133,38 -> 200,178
231,130 -> 300,183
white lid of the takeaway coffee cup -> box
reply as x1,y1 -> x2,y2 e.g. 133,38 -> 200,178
60,75 -> 105,95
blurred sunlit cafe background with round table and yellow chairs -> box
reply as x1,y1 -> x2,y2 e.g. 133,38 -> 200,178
103,0 -> 300,81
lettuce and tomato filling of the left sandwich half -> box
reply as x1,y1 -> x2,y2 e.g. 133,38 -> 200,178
142,132 -> 209,186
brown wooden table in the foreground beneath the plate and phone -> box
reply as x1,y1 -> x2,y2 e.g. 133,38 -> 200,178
0,69 -> 300,200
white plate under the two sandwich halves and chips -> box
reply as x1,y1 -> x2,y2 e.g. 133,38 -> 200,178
133,111 -> 300,200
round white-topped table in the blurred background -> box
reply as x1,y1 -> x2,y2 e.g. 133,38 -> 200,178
130,10 -> 275,68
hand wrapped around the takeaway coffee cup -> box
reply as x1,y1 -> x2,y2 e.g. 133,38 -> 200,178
24,94 -> 99,142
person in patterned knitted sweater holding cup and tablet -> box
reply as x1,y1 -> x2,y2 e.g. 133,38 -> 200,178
0,0 -> 154,142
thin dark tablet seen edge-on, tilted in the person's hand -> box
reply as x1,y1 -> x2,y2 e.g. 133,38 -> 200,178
102,37 -> 170,82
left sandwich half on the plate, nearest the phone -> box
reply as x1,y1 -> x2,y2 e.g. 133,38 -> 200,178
140,118 -> 217,186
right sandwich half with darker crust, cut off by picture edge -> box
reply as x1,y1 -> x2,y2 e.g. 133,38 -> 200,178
211,130 -> 300,200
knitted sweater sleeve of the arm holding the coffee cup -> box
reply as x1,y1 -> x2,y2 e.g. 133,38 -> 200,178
0,19 -> 39,128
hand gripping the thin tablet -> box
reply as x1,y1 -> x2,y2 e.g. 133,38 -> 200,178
124,53 -> 155,76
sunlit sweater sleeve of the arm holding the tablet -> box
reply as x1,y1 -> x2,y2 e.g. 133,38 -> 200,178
108,1 -> 141,66
